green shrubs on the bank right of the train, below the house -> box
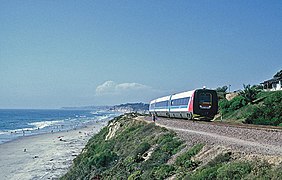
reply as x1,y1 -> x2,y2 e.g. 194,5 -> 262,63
217,85 -> 282,126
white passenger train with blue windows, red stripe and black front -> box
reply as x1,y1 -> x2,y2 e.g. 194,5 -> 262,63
149,88 -> 218,120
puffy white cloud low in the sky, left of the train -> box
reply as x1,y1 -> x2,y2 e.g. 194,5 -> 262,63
96,81 -> 152,96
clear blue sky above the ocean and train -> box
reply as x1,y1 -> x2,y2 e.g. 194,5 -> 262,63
0,0 -> 282,108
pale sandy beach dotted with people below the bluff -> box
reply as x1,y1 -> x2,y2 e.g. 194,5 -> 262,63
0,122 -> 107,180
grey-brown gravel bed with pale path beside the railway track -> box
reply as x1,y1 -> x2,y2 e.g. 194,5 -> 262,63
147,118 -> 282,156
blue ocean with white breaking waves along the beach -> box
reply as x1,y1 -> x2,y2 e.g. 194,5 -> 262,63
0,109 -> 121,144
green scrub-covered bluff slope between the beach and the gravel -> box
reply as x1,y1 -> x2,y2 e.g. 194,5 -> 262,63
61,113 -> 282,180
